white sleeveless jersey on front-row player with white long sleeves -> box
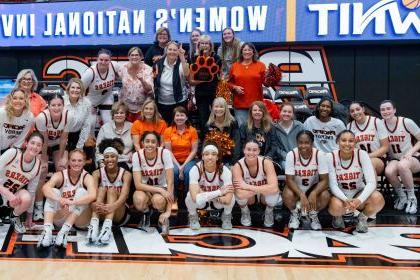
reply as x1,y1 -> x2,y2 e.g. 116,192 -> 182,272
332,149 -> 365,198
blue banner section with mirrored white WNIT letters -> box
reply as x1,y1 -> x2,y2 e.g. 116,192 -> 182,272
296,0 -> 420,42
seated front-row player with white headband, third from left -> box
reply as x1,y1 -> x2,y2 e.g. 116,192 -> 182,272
87,138 -> 131,244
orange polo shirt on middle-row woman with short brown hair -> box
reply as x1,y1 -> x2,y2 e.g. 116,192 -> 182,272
163,125 -> 198,164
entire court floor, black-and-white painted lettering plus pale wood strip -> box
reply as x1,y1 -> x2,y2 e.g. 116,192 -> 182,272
0,209 -> 420,280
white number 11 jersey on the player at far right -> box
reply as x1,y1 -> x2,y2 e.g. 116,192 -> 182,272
384,117 -> 413,159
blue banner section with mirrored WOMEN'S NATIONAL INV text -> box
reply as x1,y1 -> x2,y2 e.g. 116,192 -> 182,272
0,0 -> 286,47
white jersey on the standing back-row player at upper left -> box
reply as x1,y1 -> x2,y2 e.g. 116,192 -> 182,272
87,62 -> 116,106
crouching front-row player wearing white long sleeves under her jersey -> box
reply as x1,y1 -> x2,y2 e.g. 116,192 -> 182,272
327,130 -> 385,232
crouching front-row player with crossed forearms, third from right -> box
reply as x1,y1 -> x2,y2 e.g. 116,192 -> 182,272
232,139 -> 281,227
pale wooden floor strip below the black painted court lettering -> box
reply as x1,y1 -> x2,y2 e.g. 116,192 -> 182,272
0,260 -> 420,280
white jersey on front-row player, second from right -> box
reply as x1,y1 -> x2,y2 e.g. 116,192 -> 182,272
293,148 -> 319,192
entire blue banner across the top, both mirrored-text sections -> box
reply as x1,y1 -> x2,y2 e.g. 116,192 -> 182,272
0,0 -> 420,47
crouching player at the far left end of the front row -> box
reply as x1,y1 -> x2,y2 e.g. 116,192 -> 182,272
0,132 -> 44,233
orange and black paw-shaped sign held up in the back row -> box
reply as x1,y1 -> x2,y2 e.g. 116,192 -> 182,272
190,52 -> 220,82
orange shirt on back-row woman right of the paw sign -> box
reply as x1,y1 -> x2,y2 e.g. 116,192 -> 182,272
229,61 -> 265,109
